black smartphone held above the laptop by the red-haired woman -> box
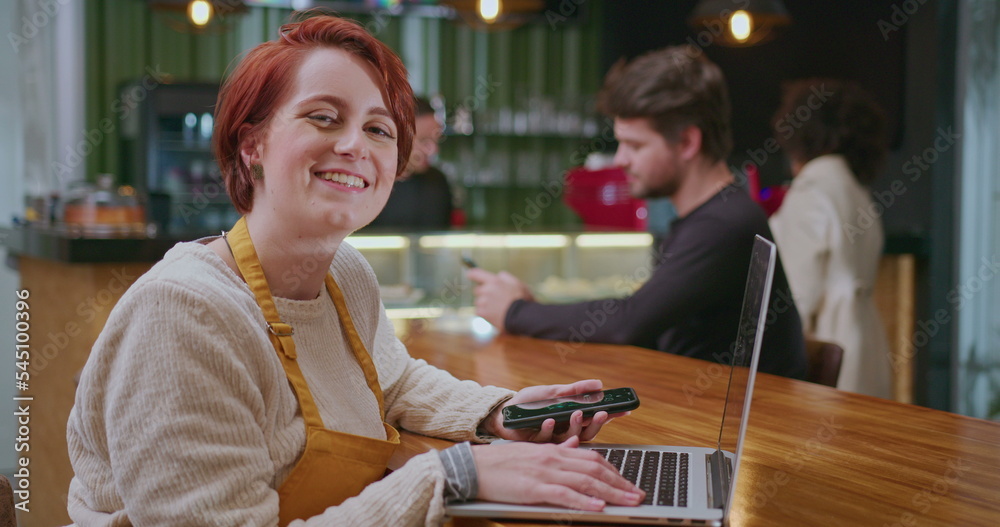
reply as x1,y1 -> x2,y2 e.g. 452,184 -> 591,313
503,388 -> 639,430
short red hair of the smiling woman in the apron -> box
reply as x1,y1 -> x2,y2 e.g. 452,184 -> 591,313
212,15 -> 414,214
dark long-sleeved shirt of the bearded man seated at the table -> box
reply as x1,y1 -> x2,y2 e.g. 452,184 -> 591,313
504,185 -> 806,378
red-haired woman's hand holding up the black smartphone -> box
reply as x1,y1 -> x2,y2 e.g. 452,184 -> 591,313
483,379 -> 628,443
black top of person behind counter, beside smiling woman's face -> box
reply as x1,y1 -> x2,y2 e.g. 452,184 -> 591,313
369,167 -> 452,230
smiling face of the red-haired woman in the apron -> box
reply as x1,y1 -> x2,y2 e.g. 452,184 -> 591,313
241,48 -> 398,237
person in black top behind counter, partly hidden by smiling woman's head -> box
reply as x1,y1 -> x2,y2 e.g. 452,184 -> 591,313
371,97 -> 453,230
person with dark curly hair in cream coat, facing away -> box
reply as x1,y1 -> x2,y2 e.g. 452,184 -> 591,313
770,79 -> 892,398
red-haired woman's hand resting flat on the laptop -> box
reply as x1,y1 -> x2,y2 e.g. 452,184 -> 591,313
472,437 -> 645,511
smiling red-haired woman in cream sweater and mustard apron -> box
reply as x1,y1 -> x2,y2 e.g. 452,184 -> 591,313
68,12 -> 643,526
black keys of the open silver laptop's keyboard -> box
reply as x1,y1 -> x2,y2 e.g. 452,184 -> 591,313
592,448 -> 688,507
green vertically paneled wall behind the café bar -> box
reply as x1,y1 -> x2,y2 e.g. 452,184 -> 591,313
85,0 -> 603,230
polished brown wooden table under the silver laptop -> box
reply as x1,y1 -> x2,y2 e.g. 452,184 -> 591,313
394,321 -> 1000,527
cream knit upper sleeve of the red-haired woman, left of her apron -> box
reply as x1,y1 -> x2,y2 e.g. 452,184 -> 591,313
68,281 -> 286,525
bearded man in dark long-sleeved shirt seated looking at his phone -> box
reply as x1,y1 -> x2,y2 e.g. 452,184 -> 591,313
467,46 -> 806,379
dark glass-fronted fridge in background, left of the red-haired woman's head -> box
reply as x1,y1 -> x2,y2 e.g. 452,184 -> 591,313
121,83 -> 239,235
